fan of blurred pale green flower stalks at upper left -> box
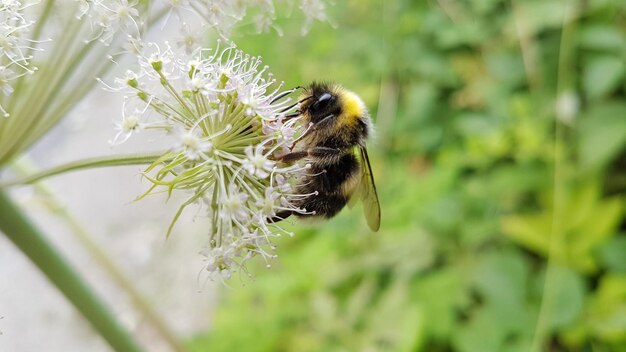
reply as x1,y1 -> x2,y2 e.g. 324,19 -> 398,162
0,0 -> 149,165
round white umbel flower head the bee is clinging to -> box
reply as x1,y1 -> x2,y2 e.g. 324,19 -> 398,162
111,43 -> 308,278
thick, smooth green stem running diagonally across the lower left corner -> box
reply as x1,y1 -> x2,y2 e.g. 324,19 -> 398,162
0,191 -> 142,352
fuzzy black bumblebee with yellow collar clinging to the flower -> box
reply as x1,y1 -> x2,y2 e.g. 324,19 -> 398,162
270,82 -> 380,231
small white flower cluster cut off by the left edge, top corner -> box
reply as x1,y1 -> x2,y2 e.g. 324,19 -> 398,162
0,0 -> 36,116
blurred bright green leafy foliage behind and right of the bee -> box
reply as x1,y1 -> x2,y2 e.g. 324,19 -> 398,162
190,0 -> 626,352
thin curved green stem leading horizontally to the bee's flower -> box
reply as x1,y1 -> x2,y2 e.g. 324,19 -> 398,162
0,152 -> 164,189
